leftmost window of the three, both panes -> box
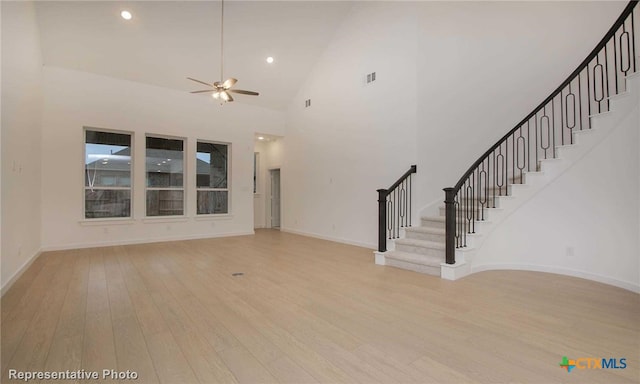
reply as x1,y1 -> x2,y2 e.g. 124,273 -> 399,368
84,129 -> 131,219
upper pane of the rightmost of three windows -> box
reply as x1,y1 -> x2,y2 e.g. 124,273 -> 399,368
196,142 -> 228,188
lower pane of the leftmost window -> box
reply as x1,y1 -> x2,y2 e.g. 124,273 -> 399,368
84,189 -> 131,219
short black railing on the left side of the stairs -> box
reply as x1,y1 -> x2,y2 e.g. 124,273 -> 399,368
377,165 -> 417,252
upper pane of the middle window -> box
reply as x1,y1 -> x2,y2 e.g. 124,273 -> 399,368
146,137 -> 184,188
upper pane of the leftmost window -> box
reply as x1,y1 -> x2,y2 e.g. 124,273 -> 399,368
84,130 -> 131,188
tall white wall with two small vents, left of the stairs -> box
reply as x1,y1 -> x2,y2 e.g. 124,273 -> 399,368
282,2 -> 417,248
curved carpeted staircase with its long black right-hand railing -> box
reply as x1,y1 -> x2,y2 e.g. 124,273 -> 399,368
375,1 -> 640,280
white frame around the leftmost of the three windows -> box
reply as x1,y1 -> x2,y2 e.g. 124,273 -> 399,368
80,126 -> 135,222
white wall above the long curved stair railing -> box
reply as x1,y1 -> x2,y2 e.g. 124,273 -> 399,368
416,1 -> 627,214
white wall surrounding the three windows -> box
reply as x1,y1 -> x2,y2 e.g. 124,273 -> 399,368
42,67 -> 284,249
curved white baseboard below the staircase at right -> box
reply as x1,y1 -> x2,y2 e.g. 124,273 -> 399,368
471,263 -> 640,293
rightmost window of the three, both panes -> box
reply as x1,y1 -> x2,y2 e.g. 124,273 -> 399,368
196,141 -> 229,215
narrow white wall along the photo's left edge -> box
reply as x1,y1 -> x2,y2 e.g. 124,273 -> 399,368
0,1 -> 42,292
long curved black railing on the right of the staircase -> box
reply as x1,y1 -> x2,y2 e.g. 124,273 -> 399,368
444,0 -> 640,264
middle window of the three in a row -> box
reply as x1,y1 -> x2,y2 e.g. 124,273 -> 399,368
146,136 -> 184,216
